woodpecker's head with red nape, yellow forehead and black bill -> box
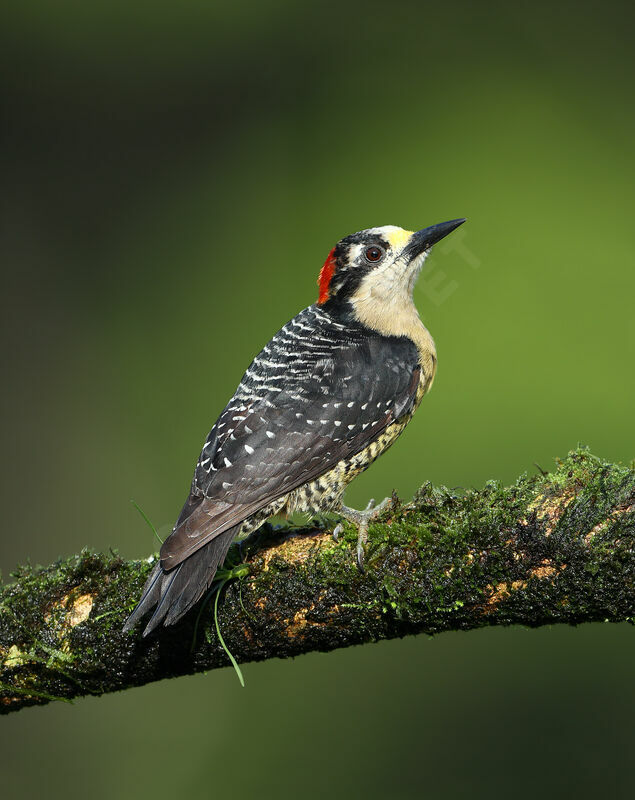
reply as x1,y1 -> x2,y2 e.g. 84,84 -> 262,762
318,219 -> 465,307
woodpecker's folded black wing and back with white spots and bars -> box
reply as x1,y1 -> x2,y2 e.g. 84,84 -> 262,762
161,318 -> 420,570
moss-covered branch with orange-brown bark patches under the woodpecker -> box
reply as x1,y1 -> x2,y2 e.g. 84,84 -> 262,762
0,450 -> 635,713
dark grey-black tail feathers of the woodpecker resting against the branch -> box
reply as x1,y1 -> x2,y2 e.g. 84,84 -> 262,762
123,528 -> 237,636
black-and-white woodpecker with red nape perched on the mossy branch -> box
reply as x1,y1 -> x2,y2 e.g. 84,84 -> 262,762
124,219 -> 465,636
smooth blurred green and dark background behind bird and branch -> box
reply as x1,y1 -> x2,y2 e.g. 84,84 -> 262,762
0,0 -> 635,800
